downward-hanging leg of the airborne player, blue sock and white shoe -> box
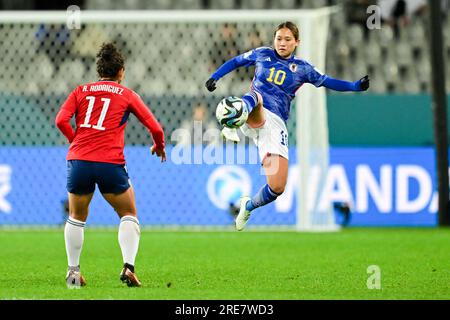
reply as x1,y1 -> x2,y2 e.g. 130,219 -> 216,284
236,154 -> 289,231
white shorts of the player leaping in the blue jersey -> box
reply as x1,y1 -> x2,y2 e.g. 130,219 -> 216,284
240,109 -> 289,162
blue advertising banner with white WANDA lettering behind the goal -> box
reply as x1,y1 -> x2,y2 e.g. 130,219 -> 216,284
0,146 -> 437,226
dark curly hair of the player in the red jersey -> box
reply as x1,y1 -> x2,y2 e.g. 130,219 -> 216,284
97,43 -> 125,79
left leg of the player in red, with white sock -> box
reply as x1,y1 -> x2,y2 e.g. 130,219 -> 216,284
64,192 -> 94,288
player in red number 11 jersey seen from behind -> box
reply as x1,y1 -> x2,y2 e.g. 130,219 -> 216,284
55,43 -> 166,288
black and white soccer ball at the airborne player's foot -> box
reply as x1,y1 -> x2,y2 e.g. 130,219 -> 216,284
216,96 -> 248,129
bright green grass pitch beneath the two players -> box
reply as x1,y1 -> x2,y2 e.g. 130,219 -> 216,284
0,228 -> 450,300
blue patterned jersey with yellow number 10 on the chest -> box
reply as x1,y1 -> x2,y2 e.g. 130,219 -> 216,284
212,47 -> 328,121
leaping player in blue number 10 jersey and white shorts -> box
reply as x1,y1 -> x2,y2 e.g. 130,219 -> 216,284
205,21 -> 369,231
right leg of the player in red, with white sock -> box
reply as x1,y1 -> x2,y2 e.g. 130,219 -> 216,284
102,186 -> 141,287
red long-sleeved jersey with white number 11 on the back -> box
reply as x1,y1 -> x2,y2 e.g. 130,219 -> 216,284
55,81 -> 164,164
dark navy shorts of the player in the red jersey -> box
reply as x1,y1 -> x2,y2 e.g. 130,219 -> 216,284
67,160 -> 130,194
